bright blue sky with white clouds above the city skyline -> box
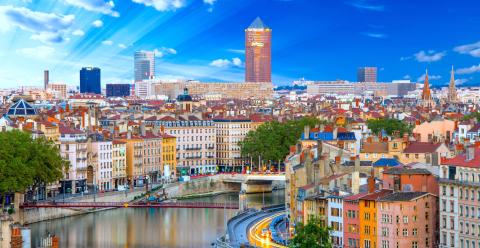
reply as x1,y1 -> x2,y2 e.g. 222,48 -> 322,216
0,0 -> 480,88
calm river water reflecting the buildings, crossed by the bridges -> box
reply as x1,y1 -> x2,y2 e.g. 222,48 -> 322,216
30,190 -> 285,248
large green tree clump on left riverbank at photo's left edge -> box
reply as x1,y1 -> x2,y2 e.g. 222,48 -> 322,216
0,130 -> 68,208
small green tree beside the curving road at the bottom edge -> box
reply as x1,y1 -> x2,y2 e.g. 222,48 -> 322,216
289,216 -> 332,248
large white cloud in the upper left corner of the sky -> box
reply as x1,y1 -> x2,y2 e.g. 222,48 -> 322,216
0,5 -> 75,43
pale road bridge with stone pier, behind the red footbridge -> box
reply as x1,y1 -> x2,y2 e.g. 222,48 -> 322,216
220,174 -> 286,193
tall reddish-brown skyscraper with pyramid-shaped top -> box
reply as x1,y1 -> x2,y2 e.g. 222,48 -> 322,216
245,17 -> 272,82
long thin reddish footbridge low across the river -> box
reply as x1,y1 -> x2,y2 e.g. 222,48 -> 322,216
20,202 -> 239,209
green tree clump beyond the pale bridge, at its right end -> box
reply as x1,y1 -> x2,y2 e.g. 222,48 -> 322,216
239,117 -> 321,170
